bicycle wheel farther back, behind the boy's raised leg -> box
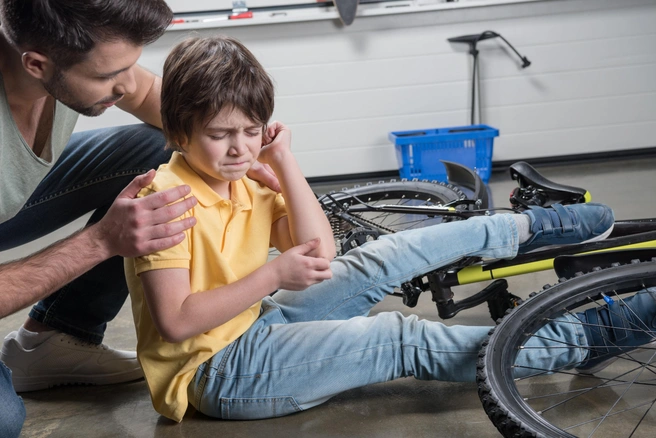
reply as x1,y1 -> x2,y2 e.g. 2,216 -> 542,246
323,181 -> 466,252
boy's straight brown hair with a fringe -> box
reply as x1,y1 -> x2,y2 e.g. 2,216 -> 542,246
161,36 -> 274,151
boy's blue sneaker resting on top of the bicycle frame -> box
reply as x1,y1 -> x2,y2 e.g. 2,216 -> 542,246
519,203 -> 615,252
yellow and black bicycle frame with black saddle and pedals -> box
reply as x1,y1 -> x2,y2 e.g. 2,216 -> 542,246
322,162 -> 656,321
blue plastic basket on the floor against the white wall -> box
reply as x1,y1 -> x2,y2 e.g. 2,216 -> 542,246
389,125 -> 499,183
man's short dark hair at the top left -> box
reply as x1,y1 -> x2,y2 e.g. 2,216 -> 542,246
0,0 -> 173,70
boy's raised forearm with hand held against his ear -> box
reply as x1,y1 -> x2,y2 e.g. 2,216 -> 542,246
259,122 -> 335,260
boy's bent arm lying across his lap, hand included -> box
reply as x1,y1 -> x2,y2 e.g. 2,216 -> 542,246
140,240 -> 332,342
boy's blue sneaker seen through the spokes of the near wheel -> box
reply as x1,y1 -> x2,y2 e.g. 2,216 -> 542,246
576,289 -> 656,374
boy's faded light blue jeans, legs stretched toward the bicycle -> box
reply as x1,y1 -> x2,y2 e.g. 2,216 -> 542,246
188,215 -> 587,419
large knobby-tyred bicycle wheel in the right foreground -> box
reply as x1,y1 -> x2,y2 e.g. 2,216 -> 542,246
477,260 -> 656,438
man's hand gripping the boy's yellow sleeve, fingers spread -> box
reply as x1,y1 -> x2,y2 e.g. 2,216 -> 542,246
93,170 -> 197,258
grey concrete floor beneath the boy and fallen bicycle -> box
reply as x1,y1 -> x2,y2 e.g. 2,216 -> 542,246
0,159 -> 656,438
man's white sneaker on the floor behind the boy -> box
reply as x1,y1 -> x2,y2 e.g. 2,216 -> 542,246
0,328 -> 143,392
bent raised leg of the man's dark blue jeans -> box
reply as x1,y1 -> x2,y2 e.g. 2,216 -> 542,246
0,124 -> 171,344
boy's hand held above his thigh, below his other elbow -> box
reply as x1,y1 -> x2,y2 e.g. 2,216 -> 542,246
271,238 -> 333,290
